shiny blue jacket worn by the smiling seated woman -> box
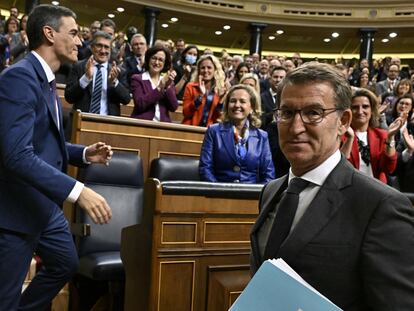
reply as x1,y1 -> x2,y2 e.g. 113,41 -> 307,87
200,123 -> 275,183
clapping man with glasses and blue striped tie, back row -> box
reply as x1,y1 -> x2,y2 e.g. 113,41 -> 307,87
65,31 -> 131,116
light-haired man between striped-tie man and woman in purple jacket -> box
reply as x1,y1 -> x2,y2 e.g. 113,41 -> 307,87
122,33 -> 147,87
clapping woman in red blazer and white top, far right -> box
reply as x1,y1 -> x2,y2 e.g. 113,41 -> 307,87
341,89 -> 404,183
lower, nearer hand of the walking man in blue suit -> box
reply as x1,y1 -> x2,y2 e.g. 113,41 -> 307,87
76,187 -> 112,225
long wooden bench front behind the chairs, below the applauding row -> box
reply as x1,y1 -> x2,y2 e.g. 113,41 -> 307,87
72,112 -> 206,178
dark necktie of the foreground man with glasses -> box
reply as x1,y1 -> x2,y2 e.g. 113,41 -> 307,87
263,177 -> 309,260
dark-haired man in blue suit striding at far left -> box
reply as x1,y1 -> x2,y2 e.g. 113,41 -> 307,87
0,5 -> 112,311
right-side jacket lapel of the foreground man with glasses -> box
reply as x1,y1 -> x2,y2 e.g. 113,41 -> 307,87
278,158 -> 354,260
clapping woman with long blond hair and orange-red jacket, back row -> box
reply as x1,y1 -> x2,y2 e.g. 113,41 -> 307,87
182,55 -> 228,126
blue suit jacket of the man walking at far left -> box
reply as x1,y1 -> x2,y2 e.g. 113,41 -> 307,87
0,53 -> 84,234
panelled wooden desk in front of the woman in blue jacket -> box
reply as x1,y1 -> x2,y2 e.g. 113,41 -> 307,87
121,179 -> 258,311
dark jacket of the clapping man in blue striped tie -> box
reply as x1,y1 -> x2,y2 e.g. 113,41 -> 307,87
65,59 -> 131,116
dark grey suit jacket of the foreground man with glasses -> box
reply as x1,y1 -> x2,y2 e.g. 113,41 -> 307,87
251,158 -> 414,311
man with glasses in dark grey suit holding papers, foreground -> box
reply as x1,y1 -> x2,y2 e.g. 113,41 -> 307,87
251,62 -> 414,311
